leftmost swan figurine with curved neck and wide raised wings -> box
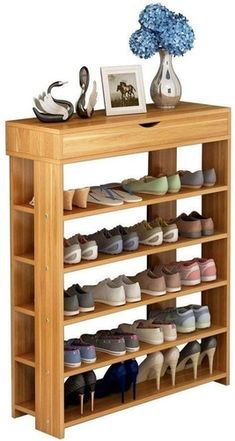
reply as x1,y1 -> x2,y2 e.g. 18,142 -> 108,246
33,81 -> 74,122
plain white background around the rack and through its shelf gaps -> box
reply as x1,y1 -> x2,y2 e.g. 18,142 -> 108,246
0,0 -> 235,441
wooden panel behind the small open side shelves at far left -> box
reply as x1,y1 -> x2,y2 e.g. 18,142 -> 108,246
10,158 -> 34,417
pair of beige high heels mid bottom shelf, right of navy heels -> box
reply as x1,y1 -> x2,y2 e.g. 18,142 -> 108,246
137,347 -> 180,390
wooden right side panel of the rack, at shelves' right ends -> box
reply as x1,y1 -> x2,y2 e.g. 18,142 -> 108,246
202,136 -> 231,384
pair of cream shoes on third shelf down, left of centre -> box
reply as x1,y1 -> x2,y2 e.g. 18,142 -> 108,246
83,275 -> 141,306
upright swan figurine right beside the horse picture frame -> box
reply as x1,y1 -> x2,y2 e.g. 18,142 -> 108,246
76,66 -> 97,119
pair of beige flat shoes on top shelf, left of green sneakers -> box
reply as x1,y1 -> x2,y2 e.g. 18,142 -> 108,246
87,186 -> 142,207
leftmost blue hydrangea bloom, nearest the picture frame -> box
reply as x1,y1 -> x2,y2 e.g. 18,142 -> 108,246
129,29 -> 159,58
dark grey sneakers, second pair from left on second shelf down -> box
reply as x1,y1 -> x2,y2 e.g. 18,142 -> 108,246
86,229 -> 123,254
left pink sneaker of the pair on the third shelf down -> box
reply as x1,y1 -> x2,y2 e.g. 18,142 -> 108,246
166,261 -> 201,286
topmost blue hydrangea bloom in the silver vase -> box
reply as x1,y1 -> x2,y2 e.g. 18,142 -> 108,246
139,3 -> 174,32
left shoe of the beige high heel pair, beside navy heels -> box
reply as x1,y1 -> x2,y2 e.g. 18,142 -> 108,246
137,352 -> 164,390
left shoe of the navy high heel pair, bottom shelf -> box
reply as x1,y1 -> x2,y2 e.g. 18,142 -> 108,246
95,363 -> 126,403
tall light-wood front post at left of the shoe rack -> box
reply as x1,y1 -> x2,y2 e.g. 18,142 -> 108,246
34,161 -> 64,438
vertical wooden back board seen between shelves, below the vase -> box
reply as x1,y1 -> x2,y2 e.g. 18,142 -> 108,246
147,148 -> 177,313
